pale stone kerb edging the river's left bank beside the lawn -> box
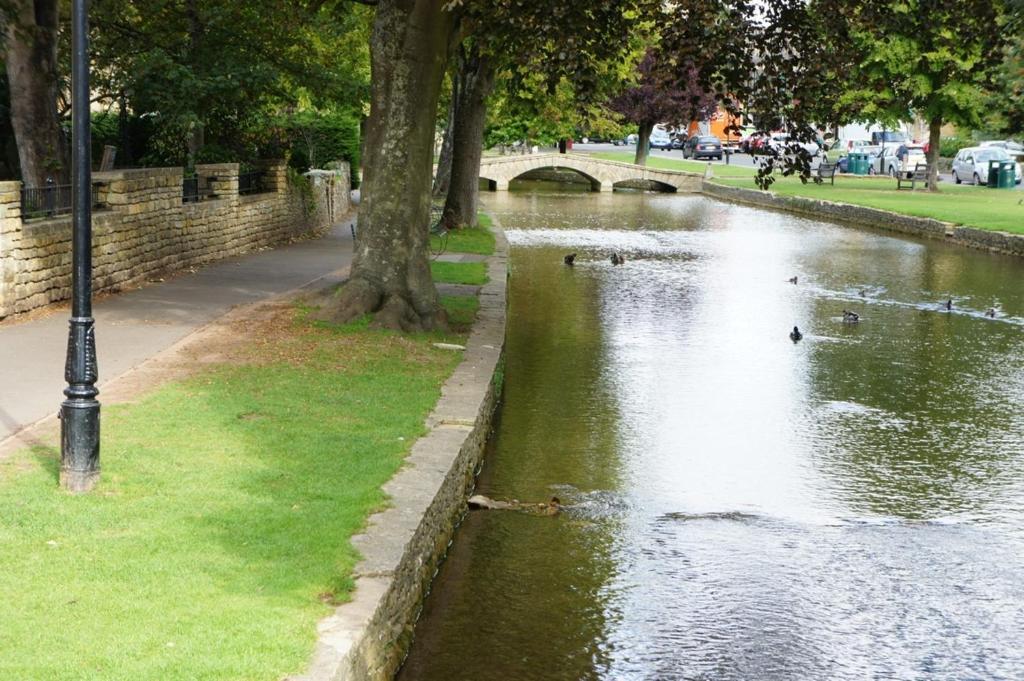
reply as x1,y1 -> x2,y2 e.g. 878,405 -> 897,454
289,221 -> 508,681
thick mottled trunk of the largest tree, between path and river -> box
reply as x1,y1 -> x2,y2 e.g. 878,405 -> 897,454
321,0 -> 452,331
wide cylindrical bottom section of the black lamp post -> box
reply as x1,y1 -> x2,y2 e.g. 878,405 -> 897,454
60,399 -> 99,494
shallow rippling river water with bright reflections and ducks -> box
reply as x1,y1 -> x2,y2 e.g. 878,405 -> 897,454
401,187 -> 1024,679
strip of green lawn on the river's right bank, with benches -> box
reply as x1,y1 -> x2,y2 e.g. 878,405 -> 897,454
716,175 -> 1024,233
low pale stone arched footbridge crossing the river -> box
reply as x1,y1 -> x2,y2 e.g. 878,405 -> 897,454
480,154 -> 703,193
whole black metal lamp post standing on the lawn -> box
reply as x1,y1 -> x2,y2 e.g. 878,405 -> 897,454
60,0 -> 99,492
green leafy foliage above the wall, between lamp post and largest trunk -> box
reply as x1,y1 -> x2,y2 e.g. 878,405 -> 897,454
91,0 -> 371,164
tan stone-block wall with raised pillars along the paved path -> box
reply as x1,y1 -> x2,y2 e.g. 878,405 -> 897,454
0,163 -> 349,318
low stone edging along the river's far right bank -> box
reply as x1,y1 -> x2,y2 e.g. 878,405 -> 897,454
703,180 -> 1024,256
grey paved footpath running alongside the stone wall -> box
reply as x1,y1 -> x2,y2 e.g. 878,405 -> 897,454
0,219 -> 352,440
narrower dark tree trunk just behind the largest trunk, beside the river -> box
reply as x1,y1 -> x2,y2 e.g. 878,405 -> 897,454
442,45 -> 495,229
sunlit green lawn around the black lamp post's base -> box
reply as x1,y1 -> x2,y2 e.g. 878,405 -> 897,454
0,298 -> 476,681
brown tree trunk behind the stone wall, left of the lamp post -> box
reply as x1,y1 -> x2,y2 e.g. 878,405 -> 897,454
4,0 -> 68,186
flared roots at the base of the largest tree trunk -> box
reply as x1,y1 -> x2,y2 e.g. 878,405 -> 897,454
312,279 -> 447,333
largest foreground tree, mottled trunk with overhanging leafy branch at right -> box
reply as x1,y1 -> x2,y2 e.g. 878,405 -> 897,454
325,0 -> 655,331
